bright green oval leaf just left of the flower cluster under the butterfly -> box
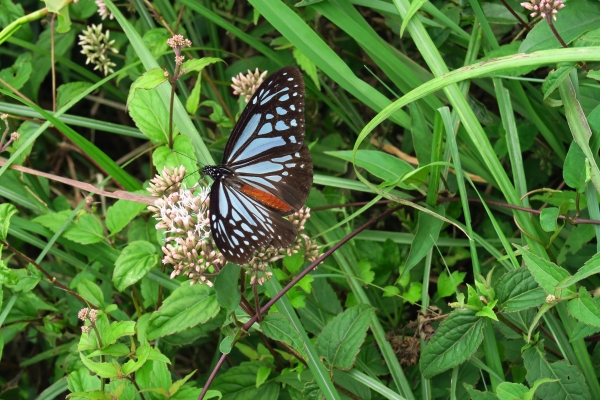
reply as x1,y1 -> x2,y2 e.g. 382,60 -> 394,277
112,240 -> 160,292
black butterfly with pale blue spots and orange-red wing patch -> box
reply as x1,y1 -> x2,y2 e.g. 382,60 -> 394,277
202,67 -> 313,265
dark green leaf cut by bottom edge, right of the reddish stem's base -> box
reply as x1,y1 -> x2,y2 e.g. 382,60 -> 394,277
211,361 -> 280,400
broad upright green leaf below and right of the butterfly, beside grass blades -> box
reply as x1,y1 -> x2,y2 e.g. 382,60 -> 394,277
316,304 -> 375,370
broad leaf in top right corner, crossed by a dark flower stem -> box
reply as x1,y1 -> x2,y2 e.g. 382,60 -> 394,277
519,0 -> 600,53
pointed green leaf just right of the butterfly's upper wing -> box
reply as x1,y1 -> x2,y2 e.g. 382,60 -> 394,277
325,150 -> 414,190
